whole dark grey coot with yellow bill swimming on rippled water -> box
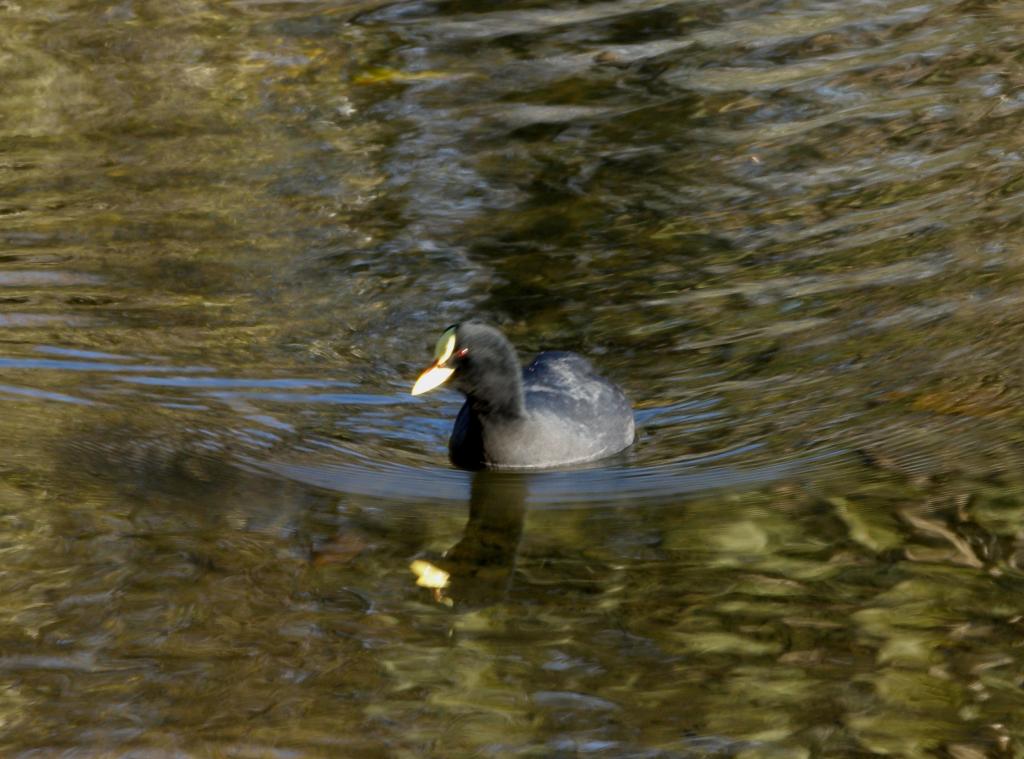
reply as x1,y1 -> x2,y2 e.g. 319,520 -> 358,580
413,322 -> 635,469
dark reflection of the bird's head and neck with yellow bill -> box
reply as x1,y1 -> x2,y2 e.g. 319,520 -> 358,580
411,471 -> 526,605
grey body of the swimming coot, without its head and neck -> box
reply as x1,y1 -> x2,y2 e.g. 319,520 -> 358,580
449,350 -> 635,469
